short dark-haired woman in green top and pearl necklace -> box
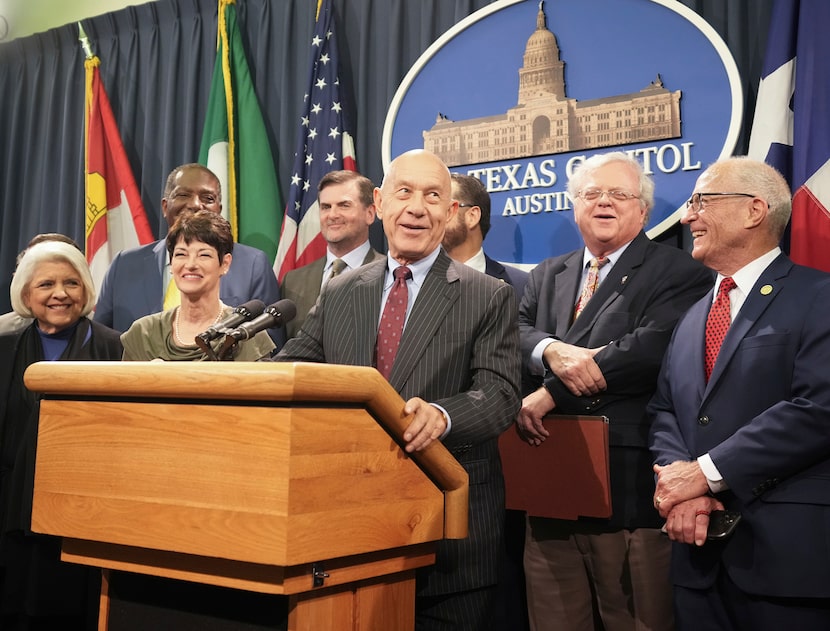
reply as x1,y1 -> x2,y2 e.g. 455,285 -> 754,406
121,210 -> 274,361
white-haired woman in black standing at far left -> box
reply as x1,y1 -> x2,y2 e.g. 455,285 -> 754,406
0,241 -> 122,630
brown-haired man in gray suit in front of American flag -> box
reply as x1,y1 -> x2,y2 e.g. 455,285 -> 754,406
280,170 -> 386,338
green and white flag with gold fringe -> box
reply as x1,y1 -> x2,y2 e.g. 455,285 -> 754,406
199,0 -> 283,263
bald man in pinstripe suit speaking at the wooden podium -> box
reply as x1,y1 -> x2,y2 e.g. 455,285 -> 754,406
275,150 -> 520,631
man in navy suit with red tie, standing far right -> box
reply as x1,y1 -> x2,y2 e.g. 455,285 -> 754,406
649,158 -> 830,631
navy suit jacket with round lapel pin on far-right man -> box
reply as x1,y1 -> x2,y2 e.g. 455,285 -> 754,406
648,255 -> 830,598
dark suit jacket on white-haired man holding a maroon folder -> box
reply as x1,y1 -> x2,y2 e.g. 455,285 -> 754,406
519,232 -> 713,531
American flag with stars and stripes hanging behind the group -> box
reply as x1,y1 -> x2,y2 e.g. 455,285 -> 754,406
274,0 -> 356,282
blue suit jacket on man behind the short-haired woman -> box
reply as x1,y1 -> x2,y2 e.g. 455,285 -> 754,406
95,239 -> 285,347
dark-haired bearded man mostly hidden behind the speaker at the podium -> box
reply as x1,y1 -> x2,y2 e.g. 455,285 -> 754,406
442,173 -> 527,300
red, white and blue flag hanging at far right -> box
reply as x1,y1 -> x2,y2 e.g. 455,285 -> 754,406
749,0 -> 830,272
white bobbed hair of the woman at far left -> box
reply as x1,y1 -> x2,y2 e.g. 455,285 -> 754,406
9,241 -> 96,318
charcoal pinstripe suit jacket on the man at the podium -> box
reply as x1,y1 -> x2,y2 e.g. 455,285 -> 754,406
275,251 -> 521,595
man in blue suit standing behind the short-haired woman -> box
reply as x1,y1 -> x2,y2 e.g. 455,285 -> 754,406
95,164 -> 284,340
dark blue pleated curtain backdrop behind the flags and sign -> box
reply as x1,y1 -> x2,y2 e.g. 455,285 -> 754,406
0,0 -> 772,313
